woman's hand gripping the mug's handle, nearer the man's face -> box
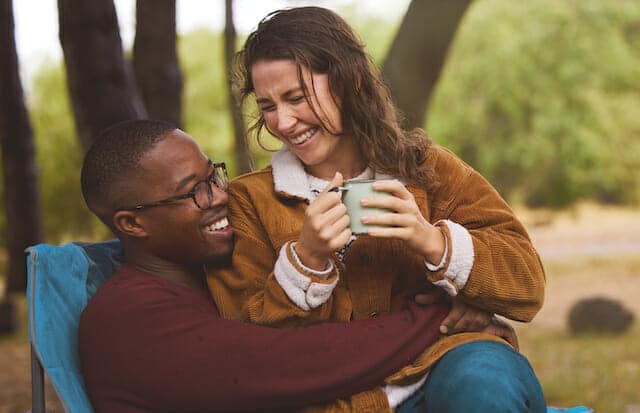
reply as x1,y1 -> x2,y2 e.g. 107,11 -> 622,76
294,172 -> 351,271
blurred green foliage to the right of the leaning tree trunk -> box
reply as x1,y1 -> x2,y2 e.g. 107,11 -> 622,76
427,0 -> 640,206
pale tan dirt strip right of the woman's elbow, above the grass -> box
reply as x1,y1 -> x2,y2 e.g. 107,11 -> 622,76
519,205 -> 640,329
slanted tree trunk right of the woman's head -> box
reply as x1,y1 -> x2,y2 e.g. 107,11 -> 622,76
382,0 -> 472,127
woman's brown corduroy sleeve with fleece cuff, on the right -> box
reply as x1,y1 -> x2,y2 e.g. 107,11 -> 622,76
428,148 -> 545,321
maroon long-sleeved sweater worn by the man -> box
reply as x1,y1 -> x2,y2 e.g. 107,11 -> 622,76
79,265 -> 448,413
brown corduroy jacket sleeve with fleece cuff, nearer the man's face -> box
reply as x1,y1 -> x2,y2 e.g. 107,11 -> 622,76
207,182 -> 338,326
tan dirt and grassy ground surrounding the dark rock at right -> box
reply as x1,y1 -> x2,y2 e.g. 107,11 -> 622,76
516,204 -> 640,413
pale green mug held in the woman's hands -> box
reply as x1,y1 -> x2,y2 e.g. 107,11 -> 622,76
337,179 -> 389,234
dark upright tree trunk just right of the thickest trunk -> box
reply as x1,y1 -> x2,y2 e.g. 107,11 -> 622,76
133,0 -> 182,127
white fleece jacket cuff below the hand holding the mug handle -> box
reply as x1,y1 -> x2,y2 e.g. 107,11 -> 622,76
273,243 -> 339,311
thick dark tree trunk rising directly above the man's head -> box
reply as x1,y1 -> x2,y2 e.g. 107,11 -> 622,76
58,0 -> 146,151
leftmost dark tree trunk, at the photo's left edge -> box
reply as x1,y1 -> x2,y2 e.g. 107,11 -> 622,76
0,0 -> 42,292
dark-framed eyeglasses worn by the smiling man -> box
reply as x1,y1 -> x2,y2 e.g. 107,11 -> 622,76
119,160 -> 229,211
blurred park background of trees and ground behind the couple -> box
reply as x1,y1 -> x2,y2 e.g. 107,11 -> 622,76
0,0 -> 640,413
